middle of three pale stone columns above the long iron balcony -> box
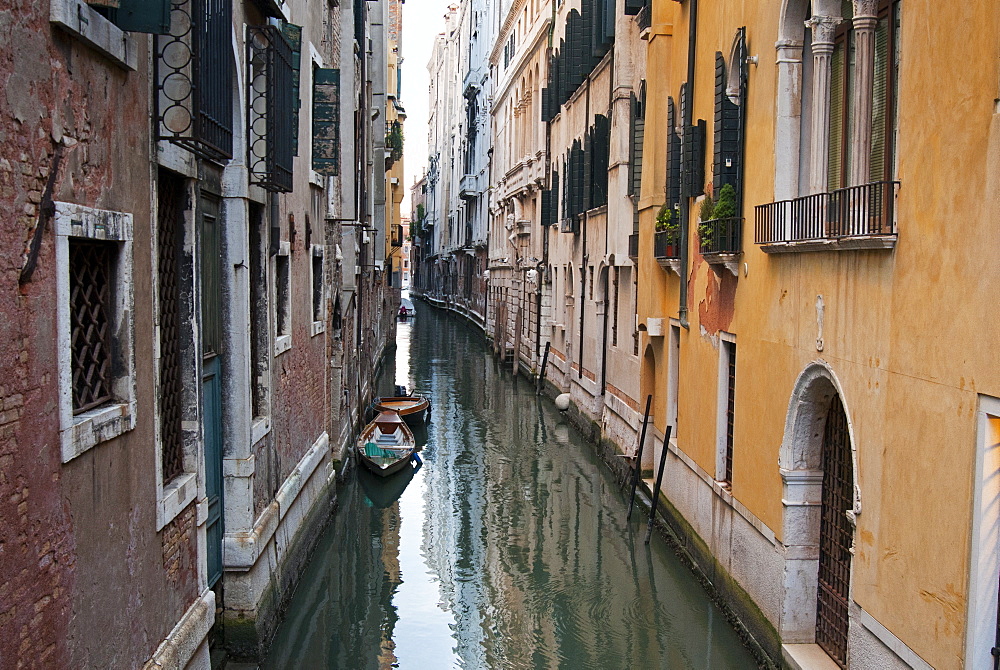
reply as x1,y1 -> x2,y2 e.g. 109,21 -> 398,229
806,16 -> 841,193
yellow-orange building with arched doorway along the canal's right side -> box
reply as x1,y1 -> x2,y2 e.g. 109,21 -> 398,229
640,0 -> 1000,669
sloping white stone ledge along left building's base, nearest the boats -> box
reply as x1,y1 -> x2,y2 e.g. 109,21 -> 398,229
222,432 -> 330,570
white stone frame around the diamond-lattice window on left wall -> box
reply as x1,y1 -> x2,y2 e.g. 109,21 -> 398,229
55,202 -> 136,463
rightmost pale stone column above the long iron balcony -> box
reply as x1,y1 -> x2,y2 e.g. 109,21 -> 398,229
849,0 -> 878,186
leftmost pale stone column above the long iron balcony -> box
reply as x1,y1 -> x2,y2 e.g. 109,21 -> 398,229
772,40 -> 802,200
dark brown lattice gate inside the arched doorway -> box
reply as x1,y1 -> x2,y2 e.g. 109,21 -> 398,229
816,395 -> 854,667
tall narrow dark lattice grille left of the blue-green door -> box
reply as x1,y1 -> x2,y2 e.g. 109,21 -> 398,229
157,175 -> 184,482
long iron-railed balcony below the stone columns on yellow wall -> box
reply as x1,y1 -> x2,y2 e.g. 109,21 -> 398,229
754,181 -> 899,253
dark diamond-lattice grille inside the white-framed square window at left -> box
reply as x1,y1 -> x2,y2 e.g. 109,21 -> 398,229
69,239 -> 117,414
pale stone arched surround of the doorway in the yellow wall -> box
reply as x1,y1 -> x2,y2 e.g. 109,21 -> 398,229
778,360 -> 861,656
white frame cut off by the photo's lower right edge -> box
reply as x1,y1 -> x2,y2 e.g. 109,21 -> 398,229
965,395 -> 1000,668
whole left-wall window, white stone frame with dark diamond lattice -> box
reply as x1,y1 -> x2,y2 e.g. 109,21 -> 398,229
55,202 -> 136,463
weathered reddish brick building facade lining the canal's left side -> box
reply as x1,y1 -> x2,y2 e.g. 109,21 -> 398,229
0,0 -> 398,667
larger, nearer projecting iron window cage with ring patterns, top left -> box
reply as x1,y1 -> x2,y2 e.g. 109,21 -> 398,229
153,0 -> 233,160
